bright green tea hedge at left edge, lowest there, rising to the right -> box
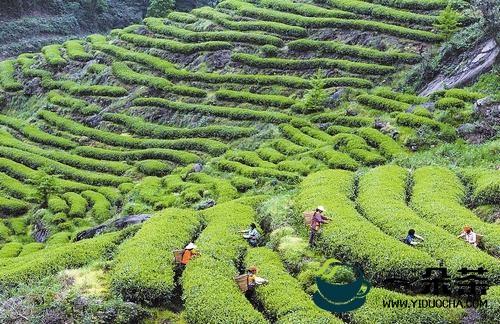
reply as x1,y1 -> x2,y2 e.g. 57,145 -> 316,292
0,233 -> 120,286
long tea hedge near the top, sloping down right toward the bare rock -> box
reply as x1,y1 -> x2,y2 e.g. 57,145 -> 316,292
219,0 -> 443,42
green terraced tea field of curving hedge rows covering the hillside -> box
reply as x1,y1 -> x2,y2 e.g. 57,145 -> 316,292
0,0 -> 500,323
